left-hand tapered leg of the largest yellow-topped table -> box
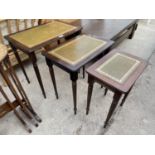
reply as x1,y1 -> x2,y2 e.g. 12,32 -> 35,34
10,43 -> 30,83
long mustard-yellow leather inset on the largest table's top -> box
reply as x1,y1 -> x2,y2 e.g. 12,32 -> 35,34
10,21 -> 76,48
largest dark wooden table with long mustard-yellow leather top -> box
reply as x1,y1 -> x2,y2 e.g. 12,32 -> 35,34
5,21 -> 81,98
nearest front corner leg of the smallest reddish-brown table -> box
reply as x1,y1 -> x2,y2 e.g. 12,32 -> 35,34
104,92 -> 122,128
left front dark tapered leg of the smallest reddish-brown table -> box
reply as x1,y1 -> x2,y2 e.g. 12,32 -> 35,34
86,75 -> 94,115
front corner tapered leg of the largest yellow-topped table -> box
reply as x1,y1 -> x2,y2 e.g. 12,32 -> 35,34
29,52 -> 46,98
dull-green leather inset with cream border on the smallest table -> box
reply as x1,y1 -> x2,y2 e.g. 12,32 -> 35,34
97,53 -> 140,83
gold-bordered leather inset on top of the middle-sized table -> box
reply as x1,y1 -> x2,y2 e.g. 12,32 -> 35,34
49,35 -> 106,64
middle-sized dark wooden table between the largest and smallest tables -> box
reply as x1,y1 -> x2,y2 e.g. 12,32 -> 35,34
43,35 -> 113,114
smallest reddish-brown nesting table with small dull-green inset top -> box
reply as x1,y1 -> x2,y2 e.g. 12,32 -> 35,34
86,50 -> 147,127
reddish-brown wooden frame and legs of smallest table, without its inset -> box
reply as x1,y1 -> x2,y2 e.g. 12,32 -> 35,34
86,50 -> 147,127
